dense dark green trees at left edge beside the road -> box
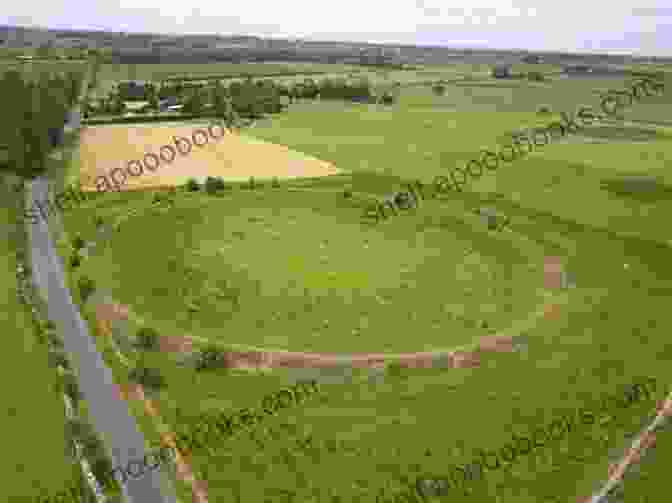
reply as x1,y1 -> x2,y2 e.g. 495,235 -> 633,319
0,67 -> 83,177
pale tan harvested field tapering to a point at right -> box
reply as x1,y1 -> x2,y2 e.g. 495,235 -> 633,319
79,123 -> 341,190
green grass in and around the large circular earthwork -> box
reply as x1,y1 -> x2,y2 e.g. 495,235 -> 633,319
57,63 -> 672,503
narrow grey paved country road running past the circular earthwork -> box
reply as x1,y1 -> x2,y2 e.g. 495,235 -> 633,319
26,81 -> 176,503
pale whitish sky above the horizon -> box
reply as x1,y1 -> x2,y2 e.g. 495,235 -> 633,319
0,0 -> 672,57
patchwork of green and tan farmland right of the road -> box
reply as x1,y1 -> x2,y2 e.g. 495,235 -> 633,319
5,42 -> 672,503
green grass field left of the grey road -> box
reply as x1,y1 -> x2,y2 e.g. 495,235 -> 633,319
0,175 -> 77,502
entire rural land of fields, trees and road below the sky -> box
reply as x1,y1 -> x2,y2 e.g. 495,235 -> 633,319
0,10 -> 672,503
